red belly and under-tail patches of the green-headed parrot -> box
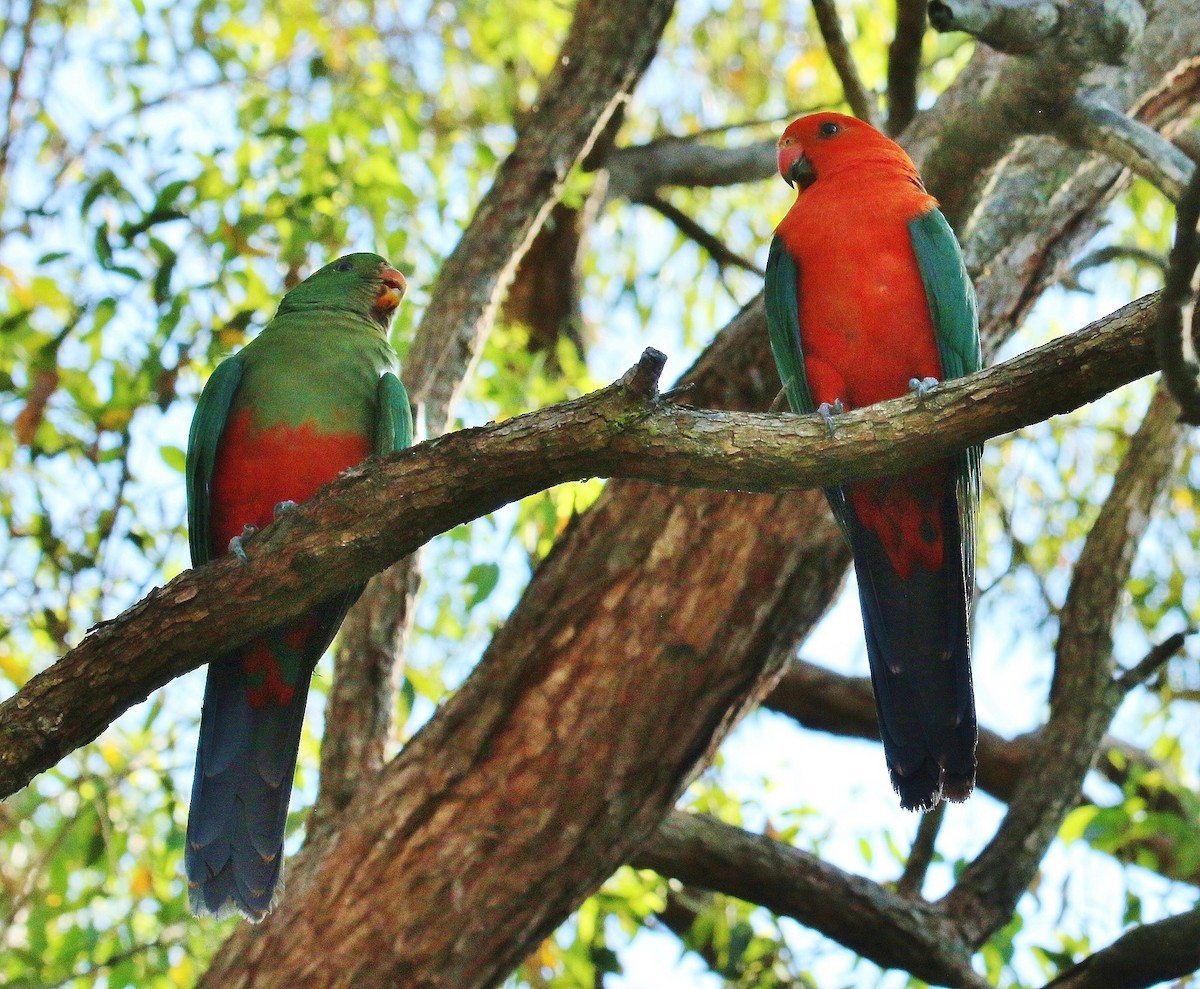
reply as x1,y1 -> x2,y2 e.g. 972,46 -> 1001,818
211,412 -> 371,708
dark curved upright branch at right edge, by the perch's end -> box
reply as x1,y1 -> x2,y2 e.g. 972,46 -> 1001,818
1156,160 -> 1200,426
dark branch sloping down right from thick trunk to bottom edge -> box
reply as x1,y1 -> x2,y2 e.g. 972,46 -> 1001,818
632,811 -> 988,989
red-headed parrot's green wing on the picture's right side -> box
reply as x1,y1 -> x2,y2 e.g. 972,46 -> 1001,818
908,209 -> 983,603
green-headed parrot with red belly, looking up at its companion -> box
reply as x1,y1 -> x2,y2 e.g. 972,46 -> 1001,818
185,254 -> 413,918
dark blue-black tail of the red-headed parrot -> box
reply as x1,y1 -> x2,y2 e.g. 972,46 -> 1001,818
846,480 -> 977,810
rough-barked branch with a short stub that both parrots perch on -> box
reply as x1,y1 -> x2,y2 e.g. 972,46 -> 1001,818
0,296 -> 1156,795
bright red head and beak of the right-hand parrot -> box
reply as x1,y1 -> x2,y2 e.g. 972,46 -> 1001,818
778,113 -> 920,192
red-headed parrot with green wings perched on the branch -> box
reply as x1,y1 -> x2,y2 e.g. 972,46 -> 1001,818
764,113 -> 980,809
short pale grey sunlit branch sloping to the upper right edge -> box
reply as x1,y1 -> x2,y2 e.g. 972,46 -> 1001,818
1057,96 -> 1195,203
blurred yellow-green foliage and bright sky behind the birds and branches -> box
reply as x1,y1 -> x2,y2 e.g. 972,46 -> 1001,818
0,0 -> 1200,989
